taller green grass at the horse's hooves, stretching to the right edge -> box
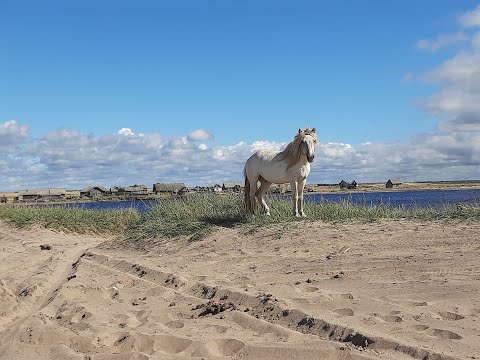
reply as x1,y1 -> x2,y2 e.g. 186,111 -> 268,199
127,194 -> 480,241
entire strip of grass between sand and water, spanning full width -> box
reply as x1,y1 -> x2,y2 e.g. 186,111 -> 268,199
0,194 -> 480,241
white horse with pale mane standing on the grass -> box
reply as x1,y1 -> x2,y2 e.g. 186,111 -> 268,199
243,128 -> 318,217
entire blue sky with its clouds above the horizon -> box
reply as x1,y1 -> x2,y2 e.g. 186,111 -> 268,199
0,0 -> 480,190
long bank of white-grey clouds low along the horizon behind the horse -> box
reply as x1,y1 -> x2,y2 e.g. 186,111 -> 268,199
0,118 -> 480,190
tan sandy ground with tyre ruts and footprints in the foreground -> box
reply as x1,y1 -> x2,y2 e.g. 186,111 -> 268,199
0,221 -> 480,360
